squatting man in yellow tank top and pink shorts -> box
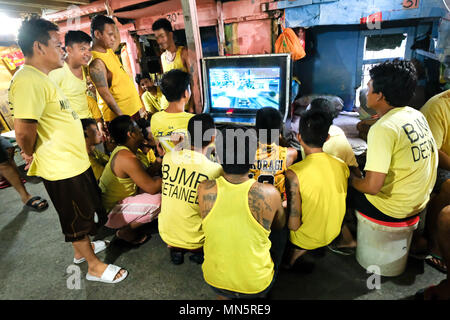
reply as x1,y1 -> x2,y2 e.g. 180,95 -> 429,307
99,115 -> 161,244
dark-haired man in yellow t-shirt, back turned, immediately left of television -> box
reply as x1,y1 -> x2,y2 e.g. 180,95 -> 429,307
151,69 -> 194,152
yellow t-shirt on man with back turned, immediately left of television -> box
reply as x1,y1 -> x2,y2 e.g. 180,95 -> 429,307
150,110 -> 194,152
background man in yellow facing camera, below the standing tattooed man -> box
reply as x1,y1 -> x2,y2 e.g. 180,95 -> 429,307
136,73 -> 167,114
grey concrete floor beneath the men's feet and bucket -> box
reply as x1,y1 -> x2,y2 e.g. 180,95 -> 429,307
0,160 -> 445,300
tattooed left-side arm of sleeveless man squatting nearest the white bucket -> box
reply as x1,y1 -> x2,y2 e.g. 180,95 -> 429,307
286,170 -> 302,231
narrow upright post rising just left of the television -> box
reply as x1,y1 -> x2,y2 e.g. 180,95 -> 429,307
181,0 -> 203,114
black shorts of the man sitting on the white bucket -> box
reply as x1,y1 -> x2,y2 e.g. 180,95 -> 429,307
347,186 -> 419,222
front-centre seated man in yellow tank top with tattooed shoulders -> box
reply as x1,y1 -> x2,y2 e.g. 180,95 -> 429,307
198,130 -> 286,299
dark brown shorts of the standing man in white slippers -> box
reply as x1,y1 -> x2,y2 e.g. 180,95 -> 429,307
43,168 -> 107,242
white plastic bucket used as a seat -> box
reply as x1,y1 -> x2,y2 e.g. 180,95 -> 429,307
356,211 -> 419,277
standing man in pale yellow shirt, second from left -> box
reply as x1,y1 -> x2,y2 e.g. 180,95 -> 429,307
48,31 -> 103,135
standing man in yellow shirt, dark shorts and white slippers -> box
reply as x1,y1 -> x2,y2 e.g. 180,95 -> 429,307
9,18 -> 127,283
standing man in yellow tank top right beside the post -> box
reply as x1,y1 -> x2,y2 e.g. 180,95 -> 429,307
152,18 -> 194,113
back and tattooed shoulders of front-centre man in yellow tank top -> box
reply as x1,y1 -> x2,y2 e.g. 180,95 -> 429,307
199,177 -> 281,294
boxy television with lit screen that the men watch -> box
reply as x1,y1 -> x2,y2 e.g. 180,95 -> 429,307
202,54 -> 292,126
